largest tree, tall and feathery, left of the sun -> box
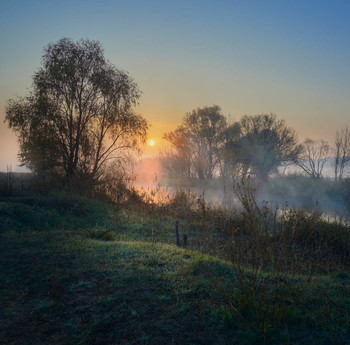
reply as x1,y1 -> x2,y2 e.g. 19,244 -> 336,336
6,38 -> 148,181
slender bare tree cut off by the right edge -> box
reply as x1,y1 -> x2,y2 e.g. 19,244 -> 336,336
334,128 -> 350,180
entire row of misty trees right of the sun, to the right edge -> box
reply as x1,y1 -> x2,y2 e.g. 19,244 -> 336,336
161,105 -> 350,181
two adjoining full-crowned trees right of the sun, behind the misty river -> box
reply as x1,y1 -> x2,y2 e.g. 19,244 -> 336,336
163,110 -> 302,180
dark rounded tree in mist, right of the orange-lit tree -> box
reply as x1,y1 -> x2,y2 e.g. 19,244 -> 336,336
225,114 -> 301,180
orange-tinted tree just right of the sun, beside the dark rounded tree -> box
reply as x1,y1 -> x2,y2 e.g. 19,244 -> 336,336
164,105 -> 227,180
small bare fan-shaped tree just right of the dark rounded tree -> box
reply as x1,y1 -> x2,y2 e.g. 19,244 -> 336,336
296,138 -> 330,178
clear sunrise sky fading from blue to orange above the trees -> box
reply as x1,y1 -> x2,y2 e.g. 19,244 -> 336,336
0,0 -> 350,170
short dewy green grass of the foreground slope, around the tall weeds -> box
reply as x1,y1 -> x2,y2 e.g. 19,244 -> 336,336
0,195 -> 350,344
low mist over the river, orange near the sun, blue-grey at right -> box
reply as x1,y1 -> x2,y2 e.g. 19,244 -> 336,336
134,154 -> 350,222
